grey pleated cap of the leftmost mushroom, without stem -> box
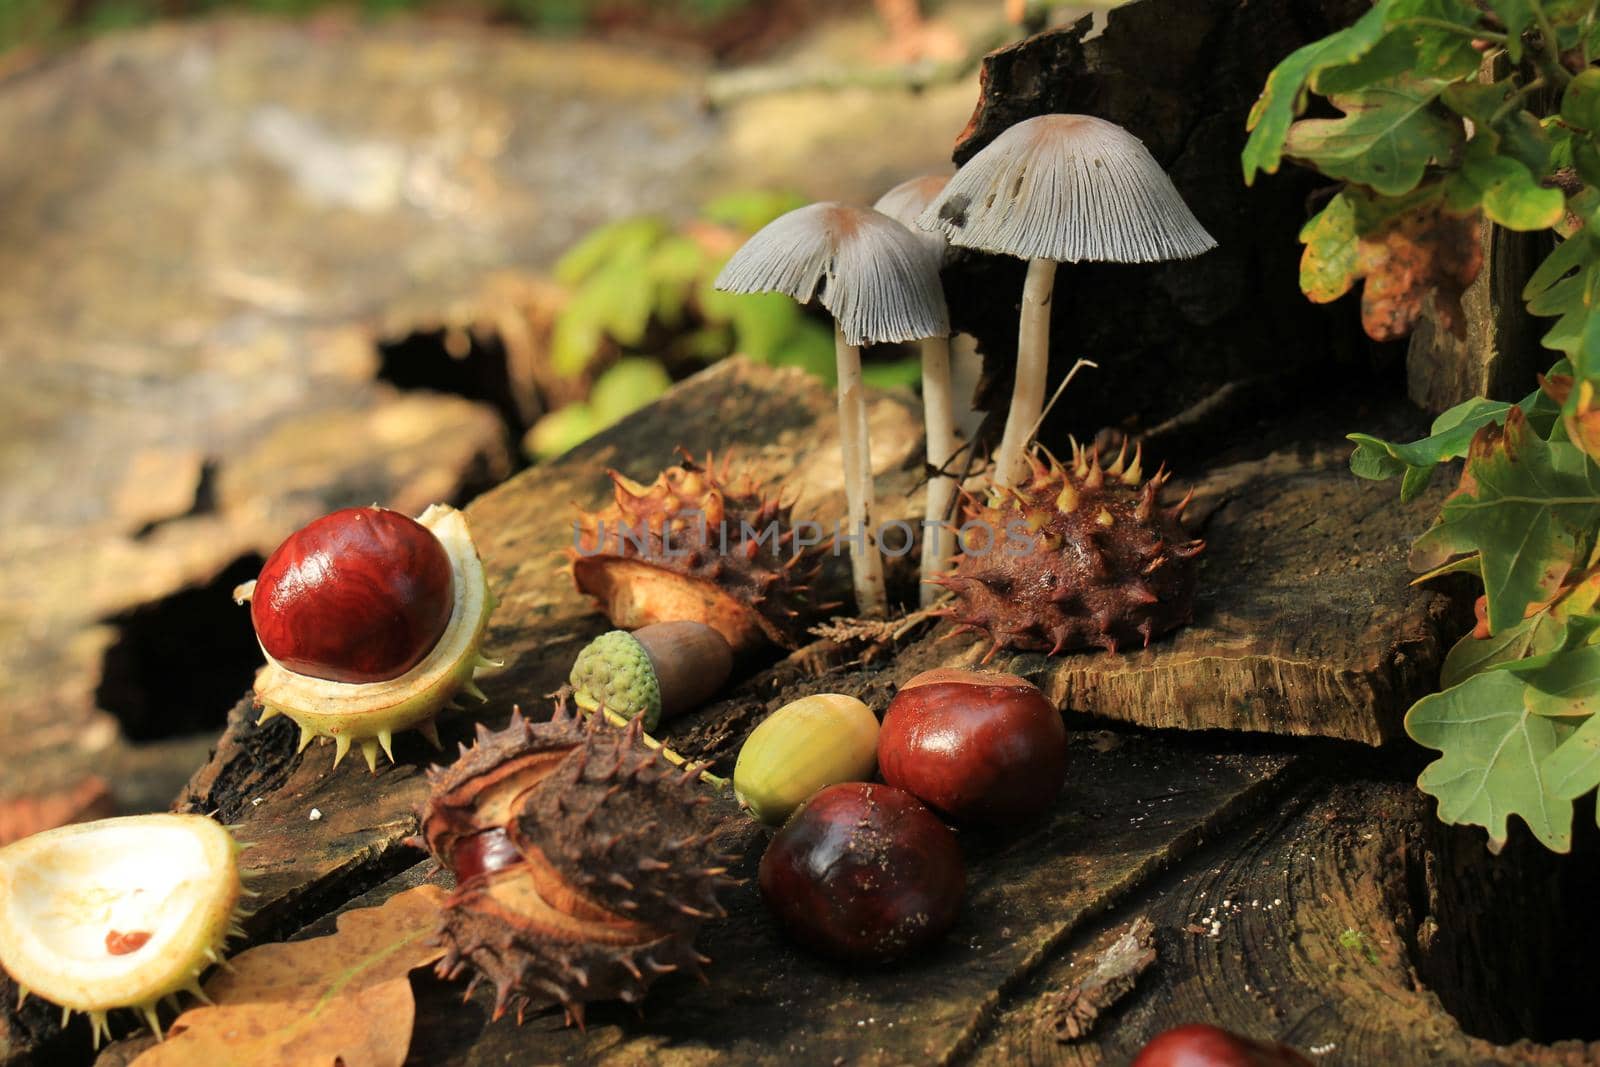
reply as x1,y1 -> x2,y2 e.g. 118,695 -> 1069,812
715,202 -> 950,344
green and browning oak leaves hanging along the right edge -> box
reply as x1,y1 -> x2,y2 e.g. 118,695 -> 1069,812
1242,0 -> 1600,851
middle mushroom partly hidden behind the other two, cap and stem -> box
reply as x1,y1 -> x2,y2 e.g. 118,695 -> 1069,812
872,174 -> 955,608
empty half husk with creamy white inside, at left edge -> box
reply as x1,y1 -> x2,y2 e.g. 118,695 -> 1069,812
0,814 -> 248,1045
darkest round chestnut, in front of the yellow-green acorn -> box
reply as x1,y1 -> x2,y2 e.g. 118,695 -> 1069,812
760,782 -> 966,963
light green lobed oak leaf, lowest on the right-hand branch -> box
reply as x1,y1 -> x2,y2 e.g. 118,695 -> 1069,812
1405,670 -> 1573,853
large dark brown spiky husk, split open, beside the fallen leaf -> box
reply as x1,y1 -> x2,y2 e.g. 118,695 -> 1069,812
418,702 -> 731,1025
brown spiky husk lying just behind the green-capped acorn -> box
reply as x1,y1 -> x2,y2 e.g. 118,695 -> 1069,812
566,450 -> 822,651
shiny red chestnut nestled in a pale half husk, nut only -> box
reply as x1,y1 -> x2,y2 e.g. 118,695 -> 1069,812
250,507 -> 454,683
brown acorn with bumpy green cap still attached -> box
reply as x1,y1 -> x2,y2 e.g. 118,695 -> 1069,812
568,621 -> 733,731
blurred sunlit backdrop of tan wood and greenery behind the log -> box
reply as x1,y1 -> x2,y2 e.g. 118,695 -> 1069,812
0,0 -> 1114,843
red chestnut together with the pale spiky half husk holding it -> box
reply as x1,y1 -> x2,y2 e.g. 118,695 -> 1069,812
234,504 -> 499,771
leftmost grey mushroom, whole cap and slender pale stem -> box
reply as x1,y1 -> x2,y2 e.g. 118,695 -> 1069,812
717,202 -> 950,617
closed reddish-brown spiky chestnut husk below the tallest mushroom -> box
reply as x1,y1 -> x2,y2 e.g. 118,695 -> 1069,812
933,442 -> 1205,659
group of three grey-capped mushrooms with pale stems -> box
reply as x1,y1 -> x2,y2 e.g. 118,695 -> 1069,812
717,115 -> 1216,617
